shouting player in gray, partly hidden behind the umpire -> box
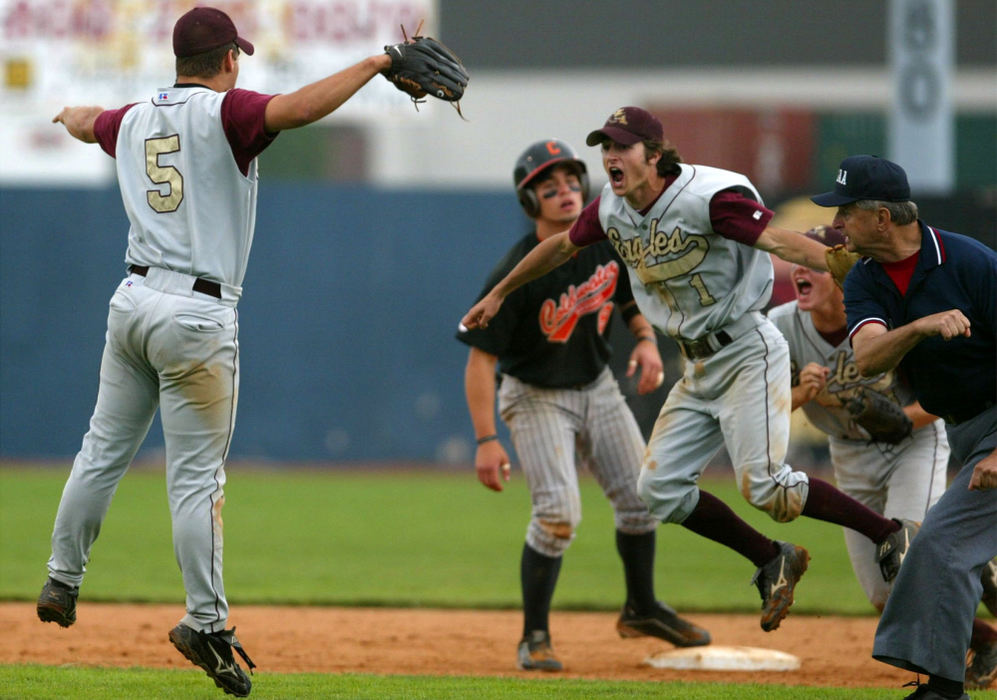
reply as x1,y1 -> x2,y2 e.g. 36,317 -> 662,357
768,226 -> 997,688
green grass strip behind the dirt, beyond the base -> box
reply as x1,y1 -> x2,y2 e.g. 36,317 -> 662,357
0,465 -> 871,615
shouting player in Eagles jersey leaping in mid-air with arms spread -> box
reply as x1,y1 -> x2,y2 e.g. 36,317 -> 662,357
462,107 -> 913,631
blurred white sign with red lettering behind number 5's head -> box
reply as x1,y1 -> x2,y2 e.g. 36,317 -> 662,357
0,0 -> 440,183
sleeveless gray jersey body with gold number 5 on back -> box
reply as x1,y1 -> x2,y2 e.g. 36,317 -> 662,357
116,87 -> 258,287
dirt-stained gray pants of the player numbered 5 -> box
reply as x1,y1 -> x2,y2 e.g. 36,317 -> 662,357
48,274 -> 239,632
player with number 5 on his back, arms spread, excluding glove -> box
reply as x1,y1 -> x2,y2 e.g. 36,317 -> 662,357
37,7 -> 416,696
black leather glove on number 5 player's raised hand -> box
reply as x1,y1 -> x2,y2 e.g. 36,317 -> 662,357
383,23 -> 468,116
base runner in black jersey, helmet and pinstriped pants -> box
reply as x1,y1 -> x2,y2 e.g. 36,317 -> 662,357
457,139 -> 710,671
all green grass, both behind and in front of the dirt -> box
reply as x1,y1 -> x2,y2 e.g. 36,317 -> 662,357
0,464 -> 997,700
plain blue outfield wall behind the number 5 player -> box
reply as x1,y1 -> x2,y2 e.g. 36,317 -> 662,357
0,182 -> 527,462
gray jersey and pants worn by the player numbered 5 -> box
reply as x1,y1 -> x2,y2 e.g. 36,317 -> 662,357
48,87 -> 272,632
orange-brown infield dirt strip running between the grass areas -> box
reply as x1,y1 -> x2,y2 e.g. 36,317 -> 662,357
0,602 -> 914,689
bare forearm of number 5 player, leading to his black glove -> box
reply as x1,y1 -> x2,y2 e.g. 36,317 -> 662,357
264,54 -> 391,134
